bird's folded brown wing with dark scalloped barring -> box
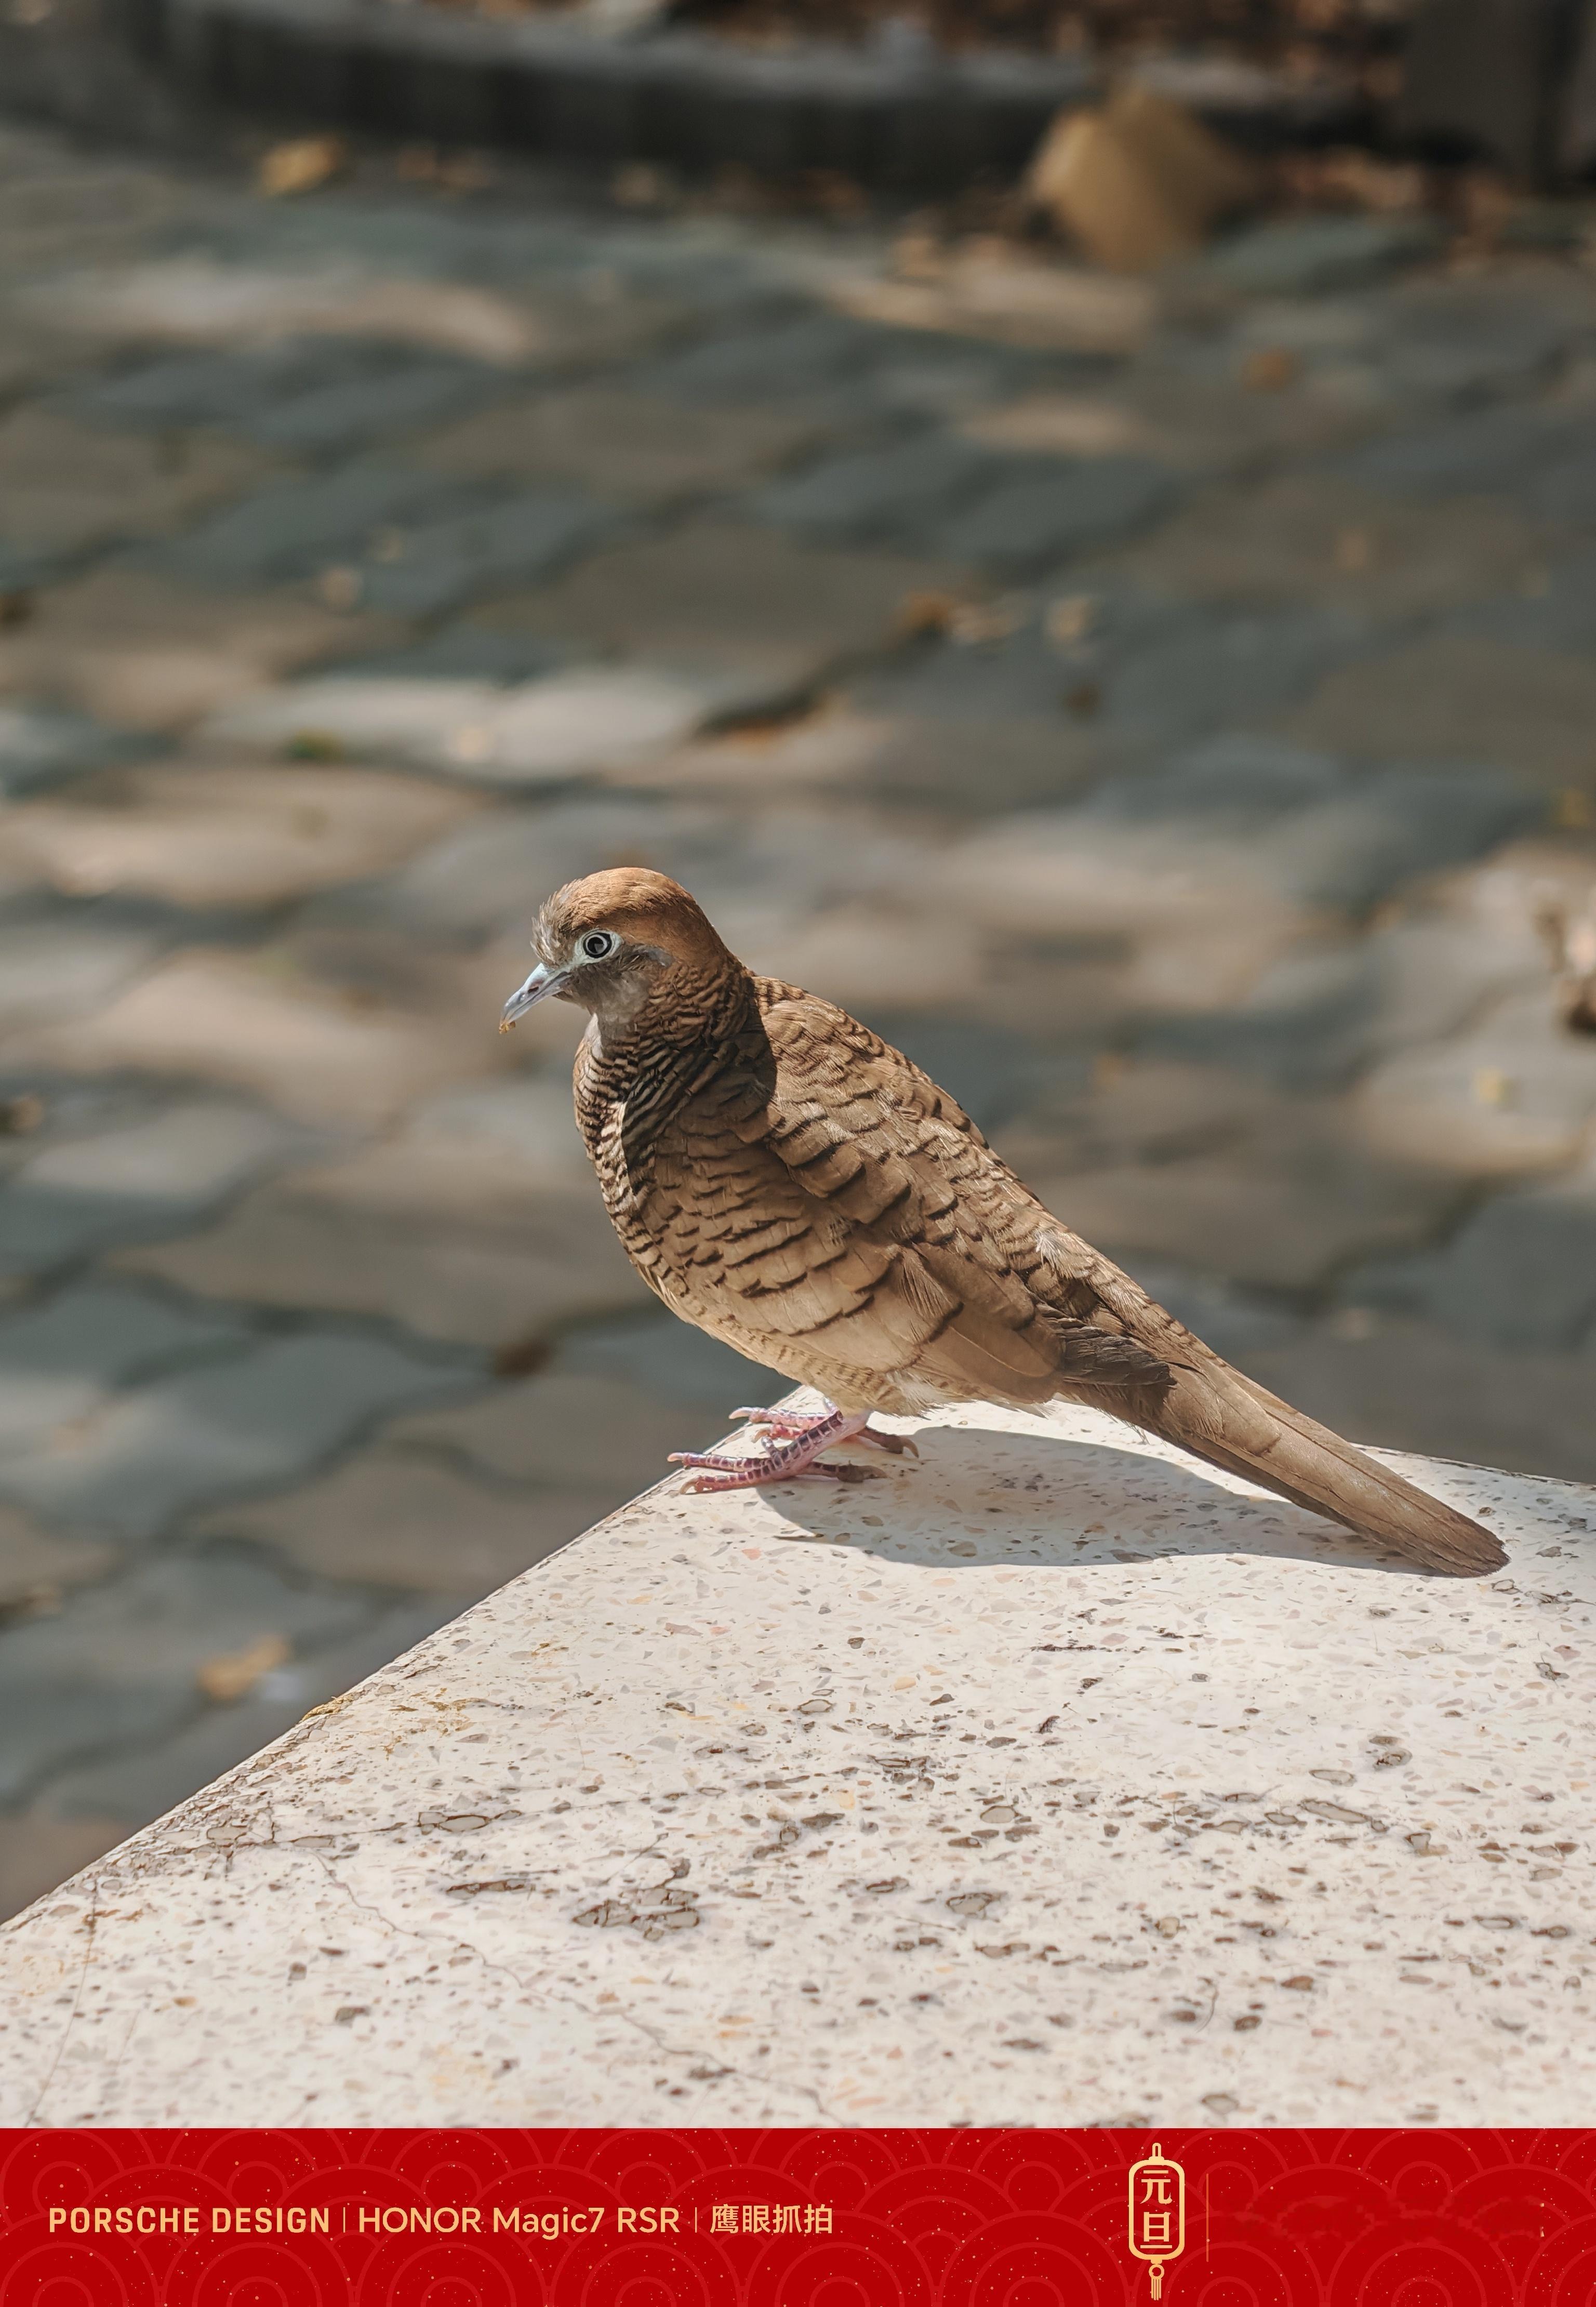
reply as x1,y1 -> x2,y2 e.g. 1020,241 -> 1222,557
650,985 -> 1167,1400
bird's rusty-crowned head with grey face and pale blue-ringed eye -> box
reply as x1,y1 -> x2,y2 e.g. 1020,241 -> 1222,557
498,865 -> 738,1033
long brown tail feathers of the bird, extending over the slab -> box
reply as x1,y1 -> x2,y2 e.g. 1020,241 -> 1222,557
1137,1352 -> 1506,1578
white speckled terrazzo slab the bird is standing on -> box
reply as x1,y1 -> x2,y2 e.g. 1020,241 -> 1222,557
0,1410 -> 1596,2125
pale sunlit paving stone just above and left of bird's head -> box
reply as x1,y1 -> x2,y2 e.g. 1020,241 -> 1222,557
205,665 -> 710,785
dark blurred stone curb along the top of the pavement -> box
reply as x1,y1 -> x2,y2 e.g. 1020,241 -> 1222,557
104,0 -> 1363,194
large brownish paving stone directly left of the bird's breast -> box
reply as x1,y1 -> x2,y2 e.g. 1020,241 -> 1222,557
122,1091 -> 644,1347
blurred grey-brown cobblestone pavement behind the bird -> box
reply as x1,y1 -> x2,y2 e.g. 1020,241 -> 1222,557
0,129 -> 1596,1908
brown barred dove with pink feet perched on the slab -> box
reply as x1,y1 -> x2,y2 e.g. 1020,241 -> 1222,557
500,867 -> 1504,1576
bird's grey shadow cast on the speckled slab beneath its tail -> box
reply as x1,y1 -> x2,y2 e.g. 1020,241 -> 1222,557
763,1426 -> 1439,1578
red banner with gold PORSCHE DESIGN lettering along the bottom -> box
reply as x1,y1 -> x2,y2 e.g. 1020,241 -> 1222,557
0,2129 -> 1596,2307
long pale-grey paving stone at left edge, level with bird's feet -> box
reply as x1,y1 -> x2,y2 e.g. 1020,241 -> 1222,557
0,1331 -> 482,1541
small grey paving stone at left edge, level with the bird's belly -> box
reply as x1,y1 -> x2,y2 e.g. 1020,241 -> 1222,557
0,1280 -> 254,1456
